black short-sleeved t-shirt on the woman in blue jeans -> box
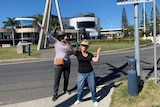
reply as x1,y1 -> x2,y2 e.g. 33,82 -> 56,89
76,51 -> 94,73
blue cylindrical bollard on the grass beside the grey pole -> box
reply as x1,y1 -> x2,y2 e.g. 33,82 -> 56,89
128,58 -> 138,96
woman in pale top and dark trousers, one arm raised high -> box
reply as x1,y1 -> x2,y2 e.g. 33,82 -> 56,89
37,22 -> 73,101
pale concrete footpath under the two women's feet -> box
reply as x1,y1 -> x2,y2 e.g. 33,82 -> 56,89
0,85 -> 114,107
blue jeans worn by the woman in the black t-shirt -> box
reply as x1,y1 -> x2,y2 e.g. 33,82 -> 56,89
77,71 -> 97,102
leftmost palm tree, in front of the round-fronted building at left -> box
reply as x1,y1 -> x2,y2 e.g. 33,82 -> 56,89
3,17 -> 19,46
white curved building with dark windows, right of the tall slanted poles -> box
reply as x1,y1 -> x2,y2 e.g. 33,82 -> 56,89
62,12 -> 100,38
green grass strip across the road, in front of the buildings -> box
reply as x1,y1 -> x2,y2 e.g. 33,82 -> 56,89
0,42 -> 133,60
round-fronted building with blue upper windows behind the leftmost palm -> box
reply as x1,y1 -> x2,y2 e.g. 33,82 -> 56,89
0,17 -> 39,45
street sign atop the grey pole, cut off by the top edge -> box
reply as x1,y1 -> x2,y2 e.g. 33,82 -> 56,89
117,0 -> 153,5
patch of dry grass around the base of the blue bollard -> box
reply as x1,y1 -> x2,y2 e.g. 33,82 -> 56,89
110,80 -> 160,107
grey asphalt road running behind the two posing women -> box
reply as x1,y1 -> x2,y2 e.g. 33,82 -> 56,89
0,45 -> 160,105
